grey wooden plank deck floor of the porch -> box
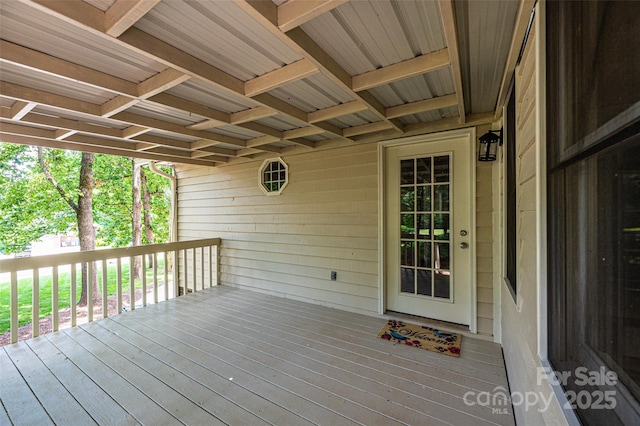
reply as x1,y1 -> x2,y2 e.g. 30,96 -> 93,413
0,286 -> 513,425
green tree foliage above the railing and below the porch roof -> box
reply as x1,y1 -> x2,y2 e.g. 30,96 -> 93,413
0,143 -> 170,254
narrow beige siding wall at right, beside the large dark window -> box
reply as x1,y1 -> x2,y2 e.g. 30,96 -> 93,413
500,13 -> 566,425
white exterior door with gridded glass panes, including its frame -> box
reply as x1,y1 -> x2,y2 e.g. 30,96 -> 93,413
384,134 -> 475,325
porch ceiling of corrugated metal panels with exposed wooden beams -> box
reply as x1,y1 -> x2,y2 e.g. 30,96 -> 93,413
0,0 -> 534,166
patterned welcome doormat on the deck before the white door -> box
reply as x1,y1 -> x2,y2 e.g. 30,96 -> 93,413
378,320 -> 462,357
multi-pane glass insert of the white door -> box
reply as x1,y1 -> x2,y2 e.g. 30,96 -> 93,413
400,155 -> 452,300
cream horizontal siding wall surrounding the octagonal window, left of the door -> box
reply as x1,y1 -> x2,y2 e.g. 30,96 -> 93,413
178,144 -> 378,313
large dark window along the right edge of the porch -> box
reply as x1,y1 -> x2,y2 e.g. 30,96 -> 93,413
546,1 -> 640,425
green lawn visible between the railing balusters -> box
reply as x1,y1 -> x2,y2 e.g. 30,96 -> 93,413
0,259 -> 164,334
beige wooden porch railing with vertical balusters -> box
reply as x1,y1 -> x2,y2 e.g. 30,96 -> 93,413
0,238 -> 220,343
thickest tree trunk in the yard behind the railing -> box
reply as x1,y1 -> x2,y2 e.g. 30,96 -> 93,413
76,152 -> 101,306
